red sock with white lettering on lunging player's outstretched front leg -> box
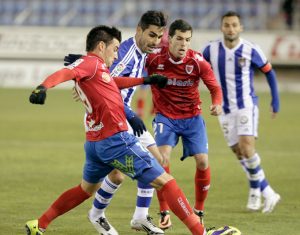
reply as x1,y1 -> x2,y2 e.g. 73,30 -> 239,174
160,179 -> 205,235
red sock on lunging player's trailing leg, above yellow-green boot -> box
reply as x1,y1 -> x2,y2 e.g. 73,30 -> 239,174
38,185 -> 91,229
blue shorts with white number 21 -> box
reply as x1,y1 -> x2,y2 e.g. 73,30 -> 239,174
153,114 -> 208,160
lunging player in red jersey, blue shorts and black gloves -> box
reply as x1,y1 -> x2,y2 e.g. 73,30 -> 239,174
26,23 -> 213,235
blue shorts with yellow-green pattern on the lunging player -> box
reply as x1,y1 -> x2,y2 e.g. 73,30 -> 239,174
83,131 -> 164,184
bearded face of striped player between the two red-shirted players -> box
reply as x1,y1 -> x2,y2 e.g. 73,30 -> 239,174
136,25 -> 165,53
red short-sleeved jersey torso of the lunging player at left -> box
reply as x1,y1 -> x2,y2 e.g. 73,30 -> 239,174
68,53 -> 128,141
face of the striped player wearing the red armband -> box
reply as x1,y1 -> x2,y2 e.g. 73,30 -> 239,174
221,16 -> 243,42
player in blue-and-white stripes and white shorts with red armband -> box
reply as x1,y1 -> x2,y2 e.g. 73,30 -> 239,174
203,12 -> 280,213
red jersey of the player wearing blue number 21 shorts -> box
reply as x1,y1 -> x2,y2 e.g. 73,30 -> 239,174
146,47 -> 222,119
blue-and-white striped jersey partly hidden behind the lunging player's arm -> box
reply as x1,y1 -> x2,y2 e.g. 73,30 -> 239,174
110,37 -> 147,106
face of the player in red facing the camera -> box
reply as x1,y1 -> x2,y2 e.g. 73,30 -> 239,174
169,30 -> 192,59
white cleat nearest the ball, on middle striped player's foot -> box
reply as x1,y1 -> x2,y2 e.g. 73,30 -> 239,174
130,215 -> 165,235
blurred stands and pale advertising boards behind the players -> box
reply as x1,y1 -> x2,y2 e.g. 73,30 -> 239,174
0,0 -> 300,89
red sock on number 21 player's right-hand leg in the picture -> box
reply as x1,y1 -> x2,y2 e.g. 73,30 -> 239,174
195,167 -> 210,211
